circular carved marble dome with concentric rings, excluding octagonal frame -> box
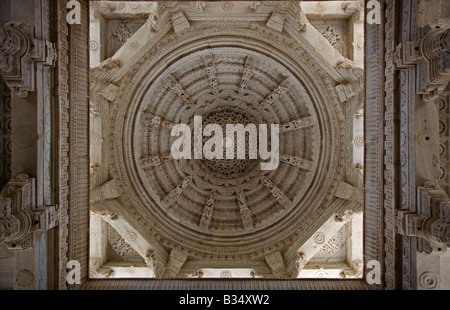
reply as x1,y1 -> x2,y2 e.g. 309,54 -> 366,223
102,21 -> 344,258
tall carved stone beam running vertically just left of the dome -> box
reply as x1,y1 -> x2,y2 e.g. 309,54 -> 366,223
59,0 -> 90,289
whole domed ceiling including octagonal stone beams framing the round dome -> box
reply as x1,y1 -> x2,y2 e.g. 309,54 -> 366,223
91,2 -> 366,278
